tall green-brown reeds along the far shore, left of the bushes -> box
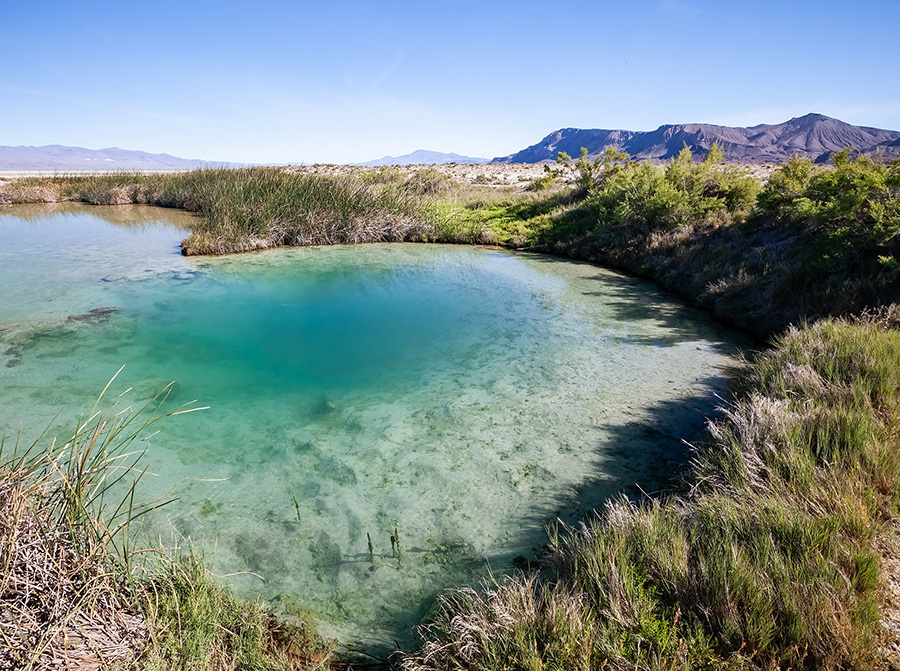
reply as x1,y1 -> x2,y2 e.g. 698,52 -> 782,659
3,168 -> 447,255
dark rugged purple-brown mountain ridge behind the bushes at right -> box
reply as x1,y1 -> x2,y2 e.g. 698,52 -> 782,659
491,114 -> 900,163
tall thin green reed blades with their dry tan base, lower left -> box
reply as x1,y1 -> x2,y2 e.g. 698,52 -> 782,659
0,376 -> 185,669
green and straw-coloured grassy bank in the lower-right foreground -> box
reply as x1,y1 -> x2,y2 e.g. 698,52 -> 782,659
403,315 -> 900,671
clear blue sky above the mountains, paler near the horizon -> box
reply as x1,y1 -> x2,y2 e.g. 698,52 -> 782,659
0,0 -> 900,163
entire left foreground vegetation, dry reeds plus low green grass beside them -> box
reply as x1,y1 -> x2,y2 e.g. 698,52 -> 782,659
0,378 -> 330,671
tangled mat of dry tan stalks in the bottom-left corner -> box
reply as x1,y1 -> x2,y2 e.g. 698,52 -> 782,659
0,468 -> 147,670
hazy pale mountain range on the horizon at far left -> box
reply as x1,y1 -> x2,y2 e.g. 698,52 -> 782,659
0,144 -> 236,171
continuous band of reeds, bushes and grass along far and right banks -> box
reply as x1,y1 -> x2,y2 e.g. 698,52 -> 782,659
4,148 -> 900,669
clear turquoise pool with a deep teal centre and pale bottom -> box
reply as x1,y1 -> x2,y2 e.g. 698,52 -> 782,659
0,205 -> 739,648
